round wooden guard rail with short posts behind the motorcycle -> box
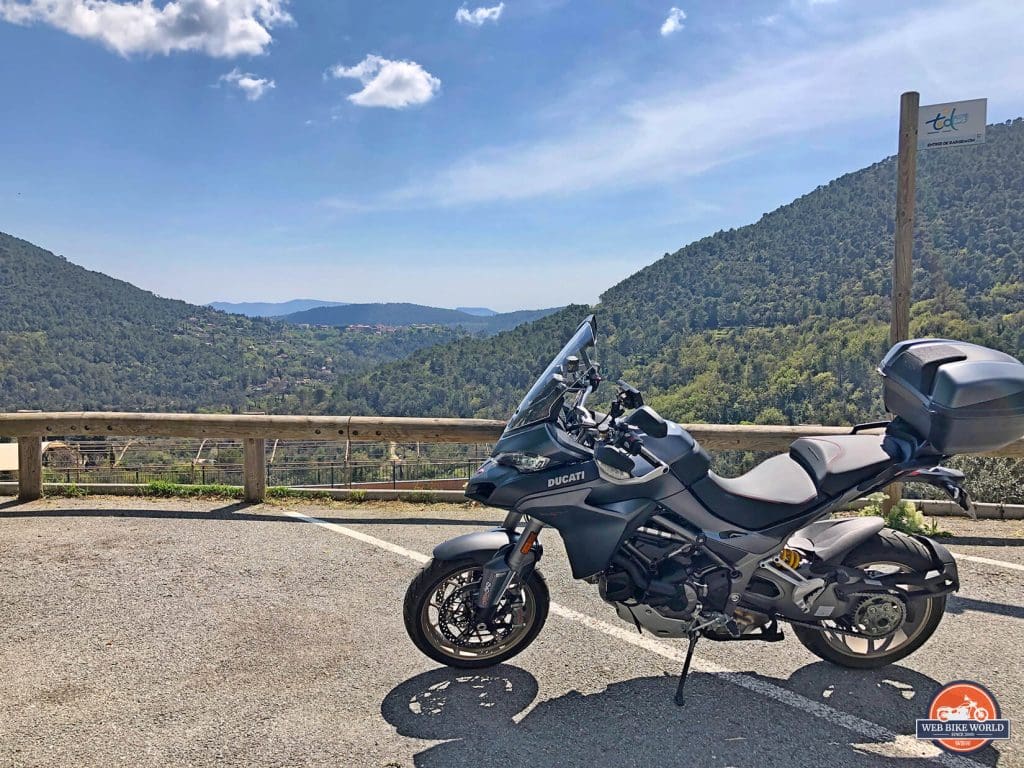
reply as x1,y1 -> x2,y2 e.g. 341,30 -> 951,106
0,412 -> 1024,502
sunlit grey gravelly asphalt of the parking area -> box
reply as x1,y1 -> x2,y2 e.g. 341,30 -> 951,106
0,498 -> 1024,768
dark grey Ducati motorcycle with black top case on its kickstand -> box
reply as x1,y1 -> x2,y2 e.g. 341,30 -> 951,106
403,315 -> 1024,703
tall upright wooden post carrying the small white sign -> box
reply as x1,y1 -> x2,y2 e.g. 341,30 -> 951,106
882,91 -> 921,513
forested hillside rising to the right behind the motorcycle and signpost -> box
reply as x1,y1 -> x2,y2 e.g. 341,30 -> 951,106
325,119 -> 1024,423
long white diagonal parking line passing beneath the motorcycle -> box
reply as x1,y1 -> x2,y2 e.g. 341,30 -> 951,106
284,510 -> 985,768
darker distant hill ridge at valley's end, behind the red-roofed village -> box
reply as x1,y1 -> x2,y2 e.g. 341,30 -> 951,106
282,303 -> 557,335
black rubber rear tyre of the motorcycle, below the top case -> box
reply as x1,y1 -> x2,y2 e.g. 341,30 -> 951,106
793,528 -> 946,670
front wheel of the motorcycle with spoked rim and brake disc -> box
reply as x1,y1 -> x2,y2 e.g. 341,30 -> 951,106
402,559 -> 550,669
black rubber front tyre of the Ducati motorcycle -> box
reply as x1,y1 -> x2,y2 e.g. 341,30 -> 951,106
402,558 -> 551,670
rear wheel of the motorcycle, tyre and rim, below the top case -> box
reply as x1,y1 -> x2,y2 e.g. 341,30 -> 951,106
793,528 -> 946,670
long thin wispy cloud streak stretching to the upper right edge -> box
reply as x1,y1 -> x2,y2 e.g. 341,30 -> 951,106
390,2 -> 1024,205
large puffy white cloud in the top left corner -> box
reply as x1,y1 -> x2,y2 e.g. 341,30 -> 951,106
0,0 -> 292,57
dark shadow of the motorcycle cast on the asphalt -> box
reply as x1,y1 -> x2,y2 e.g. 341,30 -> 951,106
381,665 -> 998,768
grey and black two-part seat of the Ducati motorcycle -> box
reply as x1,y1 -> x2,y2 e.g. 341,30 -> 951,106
690,434 -> 901,530
